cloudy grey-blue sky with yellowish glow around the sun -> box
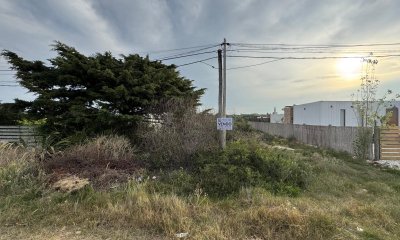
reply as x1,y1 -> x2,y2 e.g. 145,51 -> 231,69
0,0 -> 400,114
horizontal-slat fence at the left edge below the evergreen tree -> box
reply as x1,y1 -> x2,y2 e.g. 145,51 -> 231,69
0,126 -> 38,146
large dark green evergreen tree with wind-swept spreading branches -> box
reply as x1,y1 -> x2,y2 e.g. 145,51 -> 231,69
2,42 -> 204,136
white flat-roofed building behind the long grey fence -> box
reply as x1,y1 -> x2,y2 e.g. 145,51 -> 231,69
293,101 -> 400,127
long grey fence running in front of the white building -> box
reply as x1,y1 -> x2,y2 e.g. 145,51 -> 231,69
249,122 -> 357,153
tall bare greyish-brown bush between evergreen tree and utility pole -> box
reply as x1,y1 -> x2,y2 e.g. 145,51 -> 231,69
138,98 -> 218,168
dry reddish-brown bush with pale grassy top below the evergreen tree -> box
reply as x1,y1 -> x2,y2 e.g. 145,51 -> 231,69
44,136 -> 138,187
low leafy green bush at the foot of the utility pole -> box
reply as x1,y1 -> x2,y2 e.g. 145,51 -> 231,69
196,141 -> 310,197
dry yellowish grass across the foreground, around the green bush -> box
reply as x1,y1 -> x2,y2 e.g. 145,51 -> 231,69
0,136 -> 400,240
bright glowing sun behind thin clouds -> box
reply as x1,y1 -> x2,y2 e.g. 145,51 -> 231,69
336,58 -> 362,80
